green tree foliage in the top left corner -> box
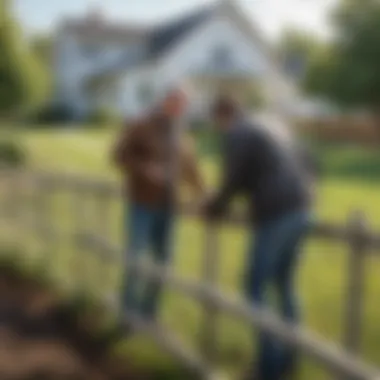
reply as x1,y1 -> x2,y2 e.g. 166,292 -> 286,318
0,0 -> 48,116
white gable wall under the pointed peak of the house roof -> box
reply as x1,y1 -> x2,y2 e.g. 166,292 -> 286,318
153,15 -> 294,113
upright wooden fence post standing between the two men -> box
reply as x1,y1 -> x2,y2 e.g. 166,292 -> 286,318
200,222 -> 219,363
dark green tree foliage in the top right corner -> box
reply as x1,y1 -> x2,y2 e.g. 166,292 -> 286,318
305,0 -> 380,113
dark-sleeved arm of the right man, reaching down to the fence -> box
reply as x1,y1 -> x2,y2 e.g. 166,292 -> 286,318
206,135 -> 246,217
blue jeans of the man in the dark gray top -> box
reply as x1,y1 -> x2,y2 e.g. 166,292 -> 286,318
246,212 -> 310,380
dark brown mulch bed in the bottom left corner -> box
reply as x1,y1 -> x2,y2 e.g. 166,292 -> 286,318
0,266 -> 152,380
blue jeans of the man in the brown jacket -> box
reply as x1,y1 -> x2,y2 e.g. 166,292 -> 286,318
122,204 -> 173,318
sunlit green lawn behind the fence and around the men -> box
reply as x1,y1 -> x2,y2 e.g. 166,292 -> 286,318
2,130 -> 380,380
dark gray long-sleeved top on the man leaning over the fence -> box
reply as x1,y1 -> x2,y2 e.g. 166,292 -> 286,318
210,119 -> 312,223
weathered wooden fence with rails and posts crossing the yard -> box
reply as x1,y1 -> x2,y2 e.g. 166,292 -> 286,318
0,170 -> 380,380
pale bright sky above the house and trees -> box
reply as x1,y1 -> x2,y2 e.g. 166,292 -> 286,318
13,0 -> 337,39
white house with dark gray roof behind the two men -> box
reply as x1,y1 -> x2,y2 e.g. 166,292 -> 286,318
55,0 -> 296,117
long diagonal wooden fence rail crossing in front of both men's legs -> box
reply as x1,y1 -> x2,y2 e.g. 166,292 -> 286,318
83,236 -> 380,380
